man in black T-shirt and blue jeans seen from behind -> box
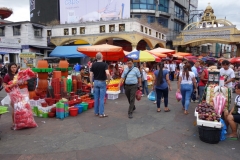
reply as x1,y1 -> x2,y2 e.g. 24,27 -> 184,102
90,52 -> 110,118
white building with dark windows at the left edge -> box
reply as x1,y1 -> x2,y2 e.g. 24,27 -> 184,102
0,21 -> 50,63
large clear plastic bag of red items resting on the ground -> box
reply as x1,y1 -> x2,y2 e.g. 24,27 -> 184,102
13,100 -> 37,130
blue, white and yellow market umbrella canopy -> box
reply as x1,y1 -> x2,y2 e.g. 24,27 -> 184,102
126,50 -> 156,62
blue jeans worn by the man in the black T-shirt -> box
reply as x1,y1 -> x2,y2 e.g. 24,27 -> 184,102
94,80 -> 106,115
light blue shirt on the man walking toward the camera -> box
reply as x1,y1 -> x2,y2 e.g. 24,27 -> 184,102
122,67 -> 141,85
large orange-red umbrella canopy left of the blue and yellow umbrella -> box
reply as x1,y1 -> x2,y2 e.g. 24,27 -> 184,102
77,44 -> 124,61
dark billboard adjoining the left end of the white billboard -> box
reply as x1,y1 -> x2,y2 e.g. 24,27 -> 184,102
29,0 -> 60,24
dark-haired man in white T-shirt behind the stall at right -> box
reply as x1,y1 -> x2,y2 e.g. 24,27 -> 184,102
220,60 -> 235,89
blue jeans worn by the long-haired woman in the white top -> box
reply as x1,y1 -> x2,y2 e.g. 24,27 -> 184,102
181,84 -> 193,111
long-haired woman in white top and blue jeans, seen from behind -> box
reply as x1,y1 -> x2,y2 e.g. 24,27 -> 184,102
177,63 -> 197,115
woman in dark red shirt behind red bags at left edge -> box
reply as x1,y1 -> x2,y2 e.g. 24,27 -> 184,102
3,63 -> 18,130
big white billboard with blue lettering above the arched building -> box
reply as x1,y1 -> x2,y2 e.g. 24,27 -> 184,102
60,0 -> 130,24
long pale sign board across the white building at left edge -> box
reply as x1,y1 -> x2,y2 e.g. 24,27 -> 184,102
0,37 -> 21,48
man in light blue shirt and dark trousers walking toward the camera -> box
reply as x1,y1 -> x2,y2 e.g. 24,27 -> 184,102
119,58 -> 142,118
